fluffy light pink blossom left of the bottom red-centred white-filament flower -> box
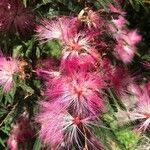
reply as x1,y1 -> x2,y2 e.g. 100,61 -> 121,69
36,102 -> 65,147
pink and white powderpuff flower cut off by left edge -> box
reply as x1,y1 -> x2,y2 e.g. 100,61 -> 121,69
0,56 -> 18,92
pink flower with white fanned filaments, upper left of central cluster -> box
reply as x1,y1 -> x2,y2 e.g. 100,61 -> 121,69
36,17 -> 78,42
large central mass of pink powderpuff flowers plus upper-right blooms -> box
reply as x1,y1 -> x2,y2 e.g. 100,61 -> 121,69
36,1 -> 141,149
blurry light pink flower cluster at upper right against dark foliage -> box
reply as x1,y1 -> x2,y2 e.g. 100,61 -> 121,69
109,5 -> 141,63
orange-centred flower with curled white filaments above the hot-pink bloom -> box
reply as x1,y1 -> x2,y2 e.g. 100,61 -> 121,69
62,33 -> 99,68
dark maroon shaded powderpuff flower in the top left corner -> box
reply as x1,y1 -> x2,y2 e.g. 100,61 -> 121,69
0,0 -> 35,36
